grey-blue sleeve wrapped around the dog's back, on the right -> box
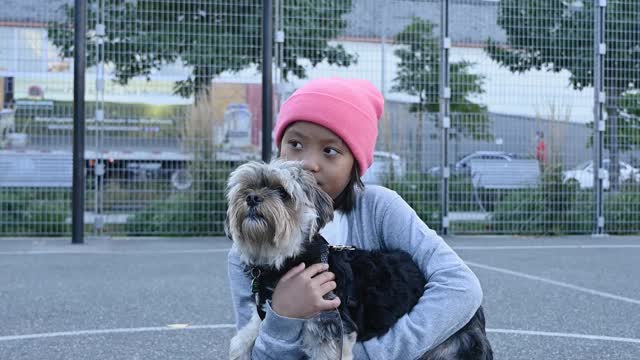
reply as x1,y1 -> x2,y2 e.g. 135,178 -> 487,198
354,193 -> 482,359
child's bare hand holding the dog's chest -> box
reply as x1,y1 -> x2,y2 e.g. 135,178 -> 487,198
271,263 -> 340,319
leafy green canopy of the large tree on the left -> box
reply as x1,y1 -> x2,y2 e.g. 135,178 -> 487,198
48,0 -> 357,97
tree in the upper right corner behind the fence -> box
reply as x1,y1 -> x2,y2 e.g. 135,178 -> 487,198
485,0 -> 640,189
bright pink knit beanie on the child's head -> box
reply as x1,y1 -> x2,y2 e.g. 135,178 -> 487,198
275,78 -> 384,176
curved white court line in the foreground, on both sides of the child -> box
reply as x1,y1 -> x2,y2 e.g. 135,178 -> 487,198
0,324 -> 640,344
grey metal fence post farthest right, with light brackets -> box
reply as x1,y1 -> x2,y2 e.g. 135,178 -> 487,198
593,0 -> 611,236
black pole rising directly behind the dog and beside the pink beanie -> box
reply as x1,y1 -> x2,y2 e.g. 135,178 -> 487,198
262,0 -> 273,162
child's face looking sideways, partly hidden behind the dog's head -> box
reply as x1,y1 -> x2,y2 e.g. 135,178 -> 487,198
280,121 -> 355,200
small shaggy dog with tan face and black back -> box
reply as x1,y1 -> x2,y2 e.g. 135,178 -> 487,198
225,160 -> 493,360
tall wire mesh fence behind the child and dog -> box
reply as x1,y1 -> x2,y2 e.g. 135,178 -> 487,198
0,0 -> 640,236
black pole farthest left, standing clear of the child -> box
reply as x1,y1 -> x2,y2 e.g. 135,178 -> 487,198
71,0 -> 87,244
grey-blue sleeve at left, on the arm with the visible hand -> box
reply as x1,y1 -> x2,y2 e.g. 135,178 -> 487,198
228,246 -> 305,360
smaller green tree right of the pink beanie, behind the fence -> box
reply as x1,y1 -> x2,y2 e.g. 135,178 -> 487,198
392,17 -> 492,164
